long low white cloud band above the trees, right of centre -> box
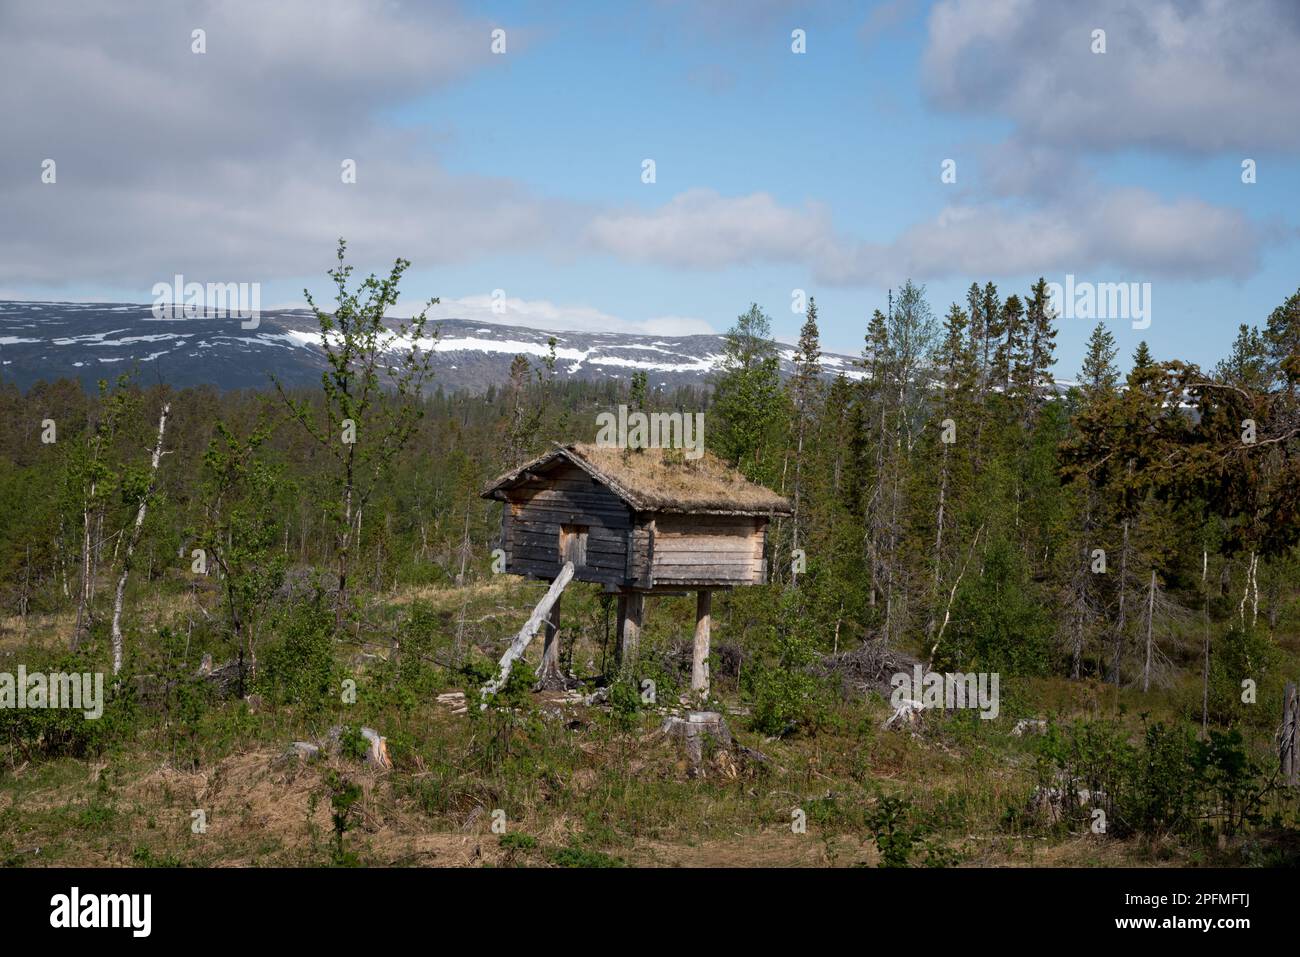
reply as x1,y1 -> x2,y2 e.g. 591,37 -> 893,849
589,190 -> 1261,286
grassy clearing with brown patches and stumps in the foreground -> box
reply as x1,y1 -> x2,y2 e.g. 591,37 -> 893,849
0,579 -> 1300,866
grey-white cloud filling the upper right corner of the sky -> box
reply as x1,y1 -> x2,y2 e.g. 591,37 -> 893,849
922,0 -> 1300,155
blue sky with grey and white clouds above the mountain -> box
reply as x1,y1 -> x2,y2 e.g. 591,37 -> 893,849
0,0 -> 1300,377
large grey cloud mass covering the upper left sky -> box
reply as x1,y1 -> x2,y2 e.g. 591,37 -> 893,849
0,0 -> 569,294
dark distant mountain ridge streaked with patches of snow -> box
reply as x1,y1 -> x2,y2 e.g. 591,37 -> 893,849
0,300 -> 863,393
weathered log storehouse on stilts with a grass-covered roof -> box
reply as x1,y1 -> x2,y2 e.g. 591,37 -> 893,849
482,445 -> 790,696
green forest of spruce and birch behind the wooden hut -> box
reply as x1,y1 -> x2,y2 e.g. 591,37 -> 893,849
0,247 -> 1300,719
